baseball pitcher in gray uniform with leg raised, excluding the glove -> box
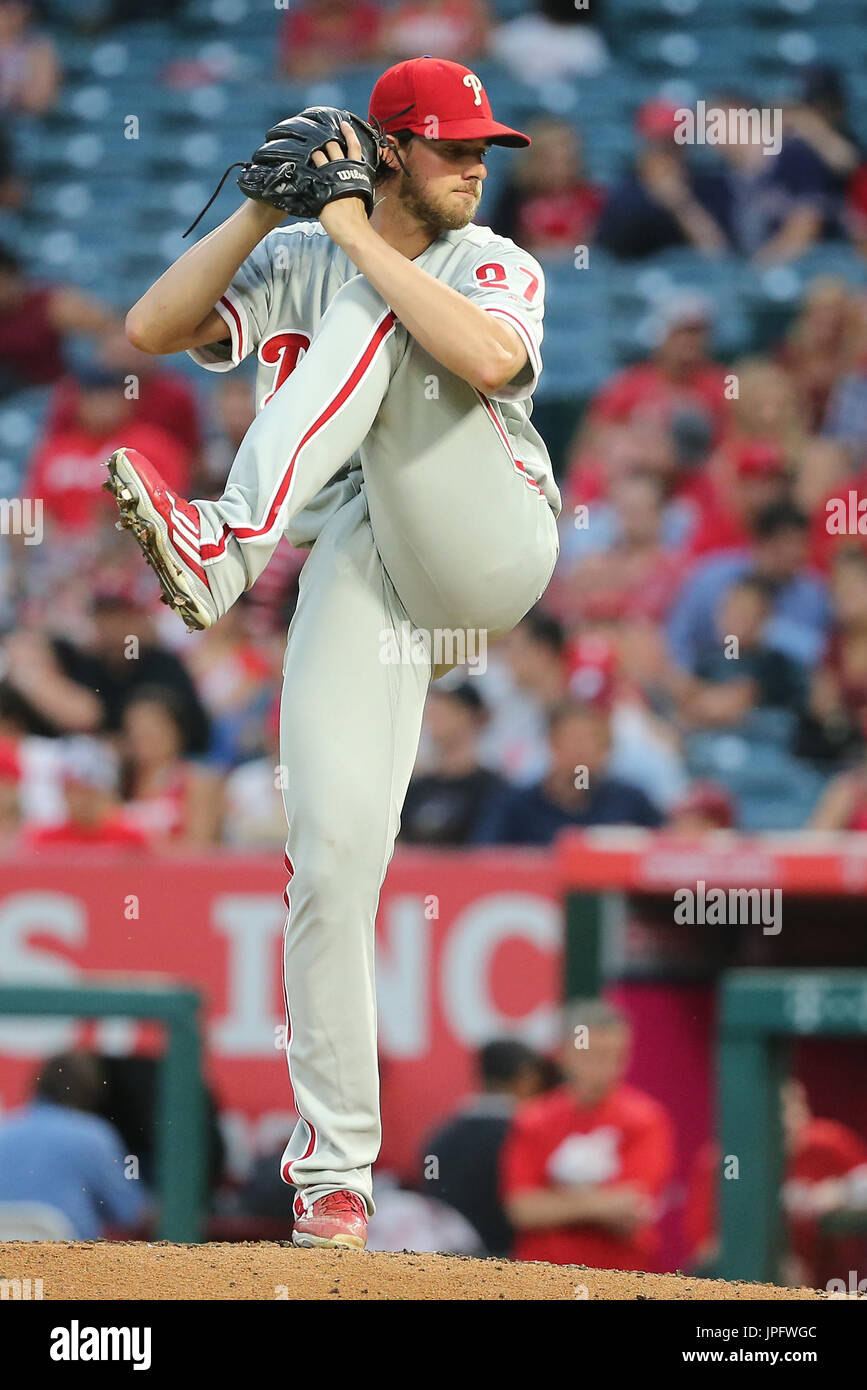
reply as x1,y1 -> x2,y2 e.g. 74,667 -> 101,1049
108,57 -> 560,1248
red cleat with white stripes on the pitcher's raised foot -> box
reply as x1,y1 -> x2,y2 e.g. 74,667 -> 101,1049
103,449 -> 220,632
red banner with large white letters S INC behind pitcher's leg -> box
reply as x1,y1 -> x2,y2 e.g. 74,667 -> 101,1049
0,851 -> 563,1172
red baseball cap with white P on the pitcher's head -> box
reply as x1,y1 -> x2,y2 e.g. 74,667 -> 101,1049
370,58 -> 532,146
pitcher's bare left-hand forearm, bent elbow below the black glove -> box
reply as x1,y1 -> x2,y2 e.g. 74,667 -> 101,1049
126,199 -> 286,354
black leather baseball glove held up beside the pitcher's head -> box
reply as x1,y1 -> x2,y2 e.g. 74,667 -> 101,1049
238,106 -> 382,218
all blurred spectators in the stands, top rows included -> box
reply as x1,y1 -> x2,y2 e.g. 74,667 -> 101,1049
0,0 -> 867,852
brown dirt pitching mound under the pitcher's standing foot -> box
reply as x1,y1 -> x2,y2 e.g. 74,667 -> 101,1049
0,1241 -> 828,1302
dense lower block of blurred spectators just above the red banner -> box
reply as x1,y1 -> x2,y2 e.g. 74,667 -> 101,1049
0,261 -> 867,848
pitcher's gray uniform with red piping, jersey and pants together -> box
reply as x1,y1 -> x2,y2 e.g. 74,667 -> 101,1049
184,214 -> 560,1211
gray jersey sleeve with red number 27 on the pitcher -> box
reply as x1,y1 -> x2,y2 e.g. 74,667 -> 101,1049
460,243 -> 545,400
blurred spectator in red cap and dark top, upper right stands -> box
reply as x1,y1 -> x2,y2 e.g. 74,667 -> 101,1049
599,99 -> 728,260
